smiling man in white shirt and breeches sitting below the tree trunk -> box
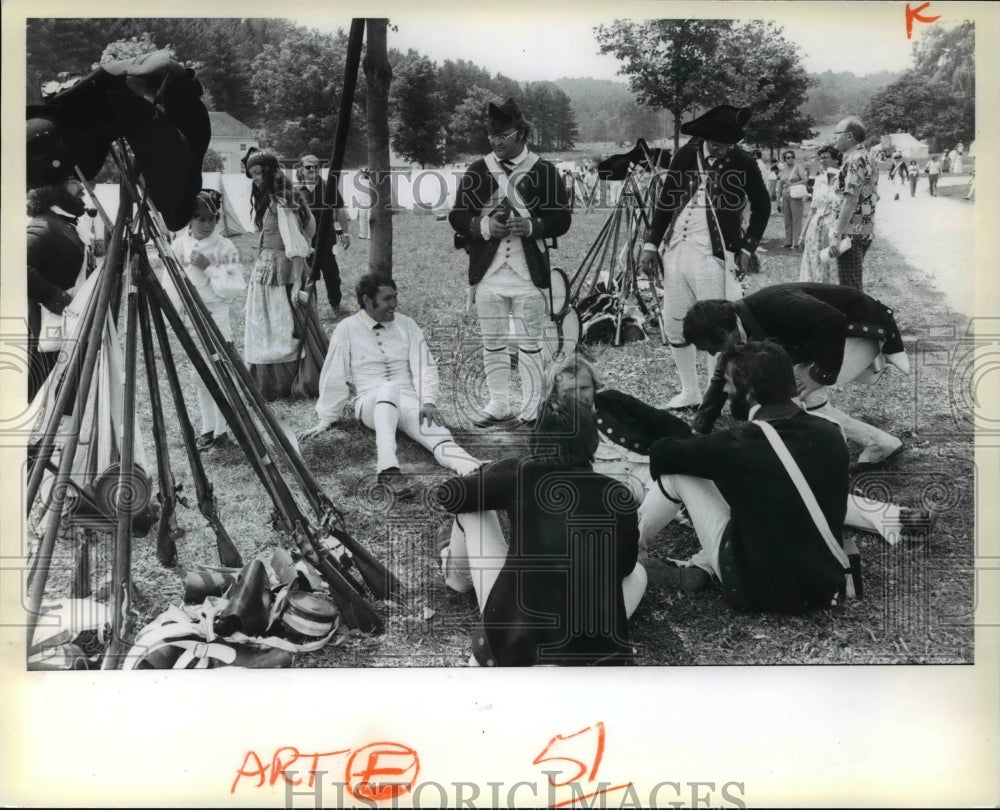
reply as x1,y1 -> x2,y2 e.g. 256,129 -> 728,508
299,273 -> 482,500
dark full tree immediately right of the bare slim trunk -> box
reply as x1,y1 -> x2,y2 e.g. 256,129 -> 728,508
390,50 -> 447,168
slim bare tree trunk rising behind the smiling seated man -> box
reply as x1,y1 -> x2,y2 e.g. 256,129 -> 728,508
362,19 -> 392,276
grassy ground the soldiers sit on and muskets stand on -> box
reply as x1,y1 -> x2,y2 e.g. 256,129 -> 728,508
43,193 -> 974,667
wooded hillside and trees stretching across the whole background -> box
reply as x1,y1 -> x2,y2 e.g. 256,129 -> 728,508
26,18 -> 975,166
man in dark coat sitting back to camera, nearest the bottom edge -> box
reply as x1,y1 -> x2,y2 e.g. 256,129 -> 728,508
435,396 -> 646,666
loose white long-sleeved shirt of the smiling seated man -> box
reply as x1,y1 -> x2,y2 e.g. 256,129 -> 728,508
316,311 -> 438,420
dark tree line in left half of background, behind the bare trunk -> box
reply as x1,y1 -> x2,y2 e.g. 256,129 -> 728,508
26,18 -> 578,166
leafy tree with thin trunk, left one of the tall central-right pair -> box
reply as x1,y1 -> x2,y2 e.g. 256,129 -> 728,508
594,20 -> 732,151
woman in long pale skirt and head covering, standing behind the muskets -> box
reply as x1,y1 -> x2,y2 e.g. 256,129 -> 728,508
243,149 -> 316,401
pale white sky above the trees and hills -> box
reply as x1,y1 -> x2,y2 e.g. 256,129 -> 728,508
295,2 -> 968,81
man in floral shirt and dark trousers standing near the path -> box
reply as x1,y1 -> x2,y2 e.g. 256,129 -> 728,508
830,115 -> 878,290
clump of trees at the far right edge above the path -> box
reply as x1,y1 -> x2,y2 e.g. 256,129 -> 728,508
862,22 -> 976,152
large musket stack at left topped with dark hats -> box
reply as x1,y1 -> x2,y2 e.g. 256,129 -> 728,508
26,36 -> 403,668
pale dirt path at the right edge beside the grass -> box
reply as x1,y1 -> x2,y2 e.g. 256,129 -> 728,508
875,175 -> 975,317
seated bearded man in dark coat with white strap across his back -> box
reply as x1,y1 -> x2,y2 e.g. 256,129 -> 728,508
644,342 -> 848,612
